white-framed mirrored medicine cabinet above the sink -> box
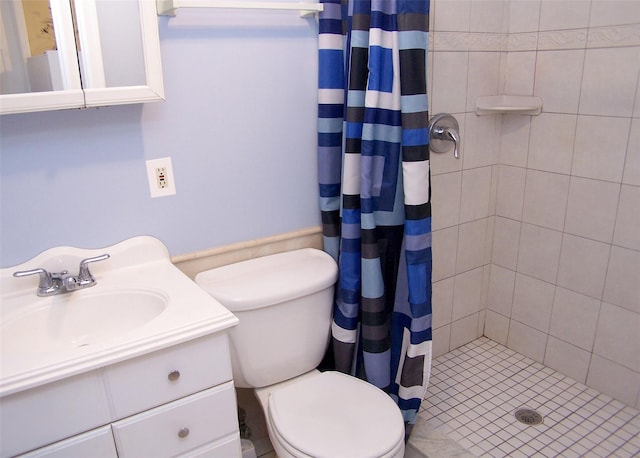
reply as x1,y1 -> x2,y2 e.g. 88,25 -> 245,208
0,0 -> 164,114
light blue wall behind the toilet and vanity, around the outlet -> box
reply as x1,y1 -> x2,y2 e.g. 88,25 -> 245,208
0,10 -> 320,267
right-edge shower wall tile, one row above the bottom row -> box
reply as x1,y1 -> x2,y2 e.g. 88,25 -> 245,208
593,302 -> 640,372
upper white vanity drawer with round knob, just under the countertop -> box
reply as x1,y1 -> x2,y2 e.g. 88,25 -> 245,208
105,333 -> 231,418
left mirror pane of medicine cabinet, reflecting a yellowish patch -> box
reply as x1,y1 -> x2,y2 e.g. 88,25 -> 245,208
0,0 -> 63,94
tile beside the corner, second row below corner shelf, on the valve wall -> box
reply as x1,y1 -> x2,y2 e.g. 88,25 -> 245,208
460,167 -> 492,223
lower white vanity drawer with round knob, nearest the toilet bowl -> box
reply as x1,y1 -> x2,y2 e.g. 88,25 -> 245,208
112,382 -> 238,458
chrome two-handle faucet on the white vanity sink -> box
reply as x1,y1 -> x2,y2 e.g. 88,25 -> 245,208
13,254 -> 110,297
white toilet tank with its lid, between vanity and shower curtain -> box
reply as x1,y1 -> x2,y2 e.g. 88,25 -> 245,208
195,248 -> 338,388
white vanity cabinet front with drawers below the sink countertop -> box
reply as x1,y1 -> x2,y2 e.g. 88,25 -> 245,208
0,332 -> 241,458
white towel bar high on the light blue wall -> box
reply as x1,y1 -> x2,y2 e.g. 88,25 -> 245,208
156,0 -> 324,17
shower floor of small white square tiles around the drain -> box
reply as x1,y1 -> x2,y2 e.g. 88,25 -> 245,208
405,337 -> 640,458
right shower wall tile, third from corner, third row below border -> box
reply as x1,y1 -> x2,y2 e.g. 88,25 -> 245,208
564,177 -> 620,243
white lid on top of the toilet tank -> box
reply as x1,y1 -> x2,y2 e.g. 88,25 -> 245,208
195,248 -> 338,312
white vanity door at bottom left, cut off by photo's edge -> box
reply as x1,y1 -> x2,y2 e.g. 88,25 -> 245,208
20,426 -> 118,458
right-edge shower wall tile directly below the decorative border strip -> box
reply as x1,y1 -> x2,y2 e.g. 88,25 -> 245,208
579,47 -> 640,116
